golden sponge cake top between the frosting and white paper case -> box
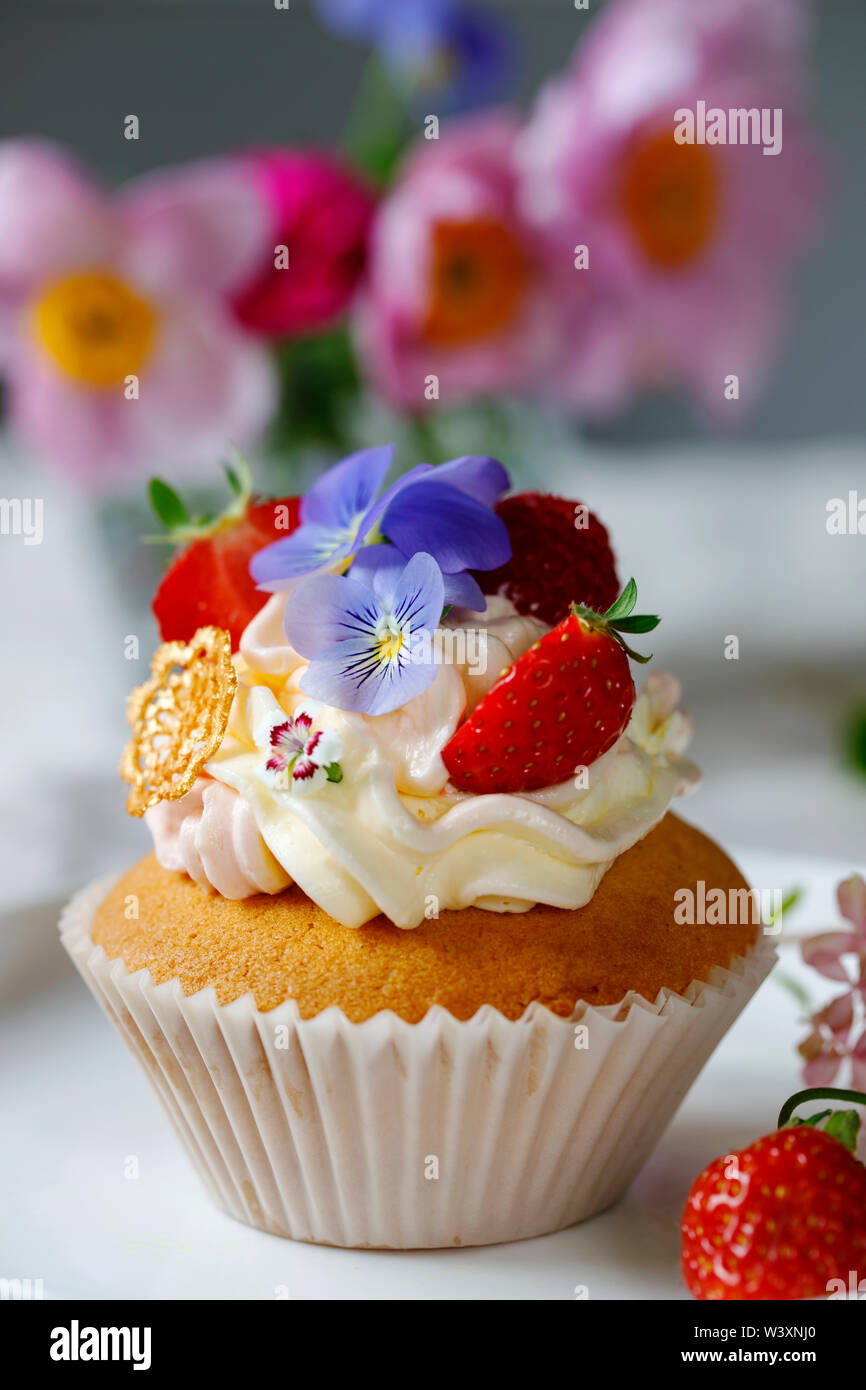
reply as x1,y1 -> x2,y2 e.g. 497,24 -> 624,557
92,813 -> 759,1023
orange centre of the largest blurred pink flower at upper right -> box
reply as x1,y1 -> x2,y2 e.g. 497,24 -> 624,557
620,131 -> 719,270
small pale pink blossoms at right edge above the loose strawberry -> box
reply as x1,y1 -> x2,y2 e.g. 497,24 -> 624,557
799,874 -> 866,1090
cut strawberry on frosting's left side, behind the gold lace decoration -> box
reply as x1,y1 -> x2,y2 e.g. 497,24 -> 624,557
153,475 -> 300,651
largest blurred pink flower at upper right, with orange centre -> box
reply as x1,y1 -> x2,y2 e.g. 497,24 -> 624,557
518,0 -> 820,414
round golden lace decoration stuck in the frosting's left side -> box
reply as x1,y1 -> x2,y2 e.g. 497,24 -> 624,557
121,627 -> 238,816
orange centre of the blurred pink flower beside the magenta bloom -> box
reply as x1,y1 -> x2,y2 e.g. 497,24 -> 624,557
424,218 -> 527,348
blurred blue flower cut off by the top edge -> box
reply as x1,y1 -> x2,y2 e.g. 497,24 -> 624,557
316,0 -> 514,115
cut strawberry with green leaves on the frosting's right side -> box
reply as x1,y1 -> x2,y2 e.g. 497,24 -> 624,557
442,580 -> 659,792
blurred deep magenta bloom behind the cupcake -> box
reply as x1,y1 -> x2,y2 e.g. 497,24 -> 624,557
235,150 -> 374,338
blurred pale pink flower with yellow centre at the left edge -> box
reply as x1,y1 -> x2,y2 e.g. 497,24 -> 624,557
0,139 -> 277,487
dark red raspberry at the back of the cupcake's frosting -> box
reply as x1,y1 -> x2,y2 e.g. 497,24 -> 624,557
475,492 -> 620,626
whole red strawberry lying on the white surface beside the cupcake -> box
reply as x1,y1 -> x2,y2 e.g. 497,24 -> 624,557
681,1087 -> 866,1300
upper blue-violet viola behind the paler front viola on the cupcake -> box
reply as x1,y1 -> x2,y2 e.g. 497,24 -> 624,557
250,445 -> 512,602
